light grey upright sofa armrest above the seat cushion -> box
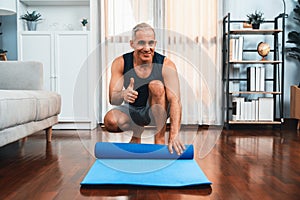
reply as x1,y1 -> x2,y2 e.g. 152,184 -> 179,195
0,61 -> 43,90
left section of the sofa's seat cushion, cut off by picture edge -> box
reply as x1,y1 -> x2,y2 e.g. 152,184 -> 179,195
0,90 -> 37,130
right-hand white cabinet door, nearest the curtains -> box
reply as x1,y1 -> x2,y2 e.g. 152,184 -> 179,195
55,32 -> 91,123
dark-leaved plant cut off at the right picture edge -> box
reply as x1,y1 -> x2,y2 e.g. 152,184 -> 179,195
286,0 -> 300,63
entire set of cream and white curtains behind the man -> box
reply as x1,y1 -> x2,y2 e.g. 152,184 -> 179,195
100,0 -> 222,125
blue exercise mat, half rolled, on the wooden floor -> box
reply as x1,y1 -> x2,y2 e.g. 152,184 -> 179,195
81,142 -> 211,187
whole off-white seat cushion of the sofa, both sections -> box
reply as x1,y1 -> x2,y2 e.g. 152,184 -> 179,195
0,90 -> 61,130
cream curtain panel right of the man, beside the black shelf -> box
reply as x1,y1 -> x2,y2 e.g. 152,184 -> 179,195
165,0 -> 222,124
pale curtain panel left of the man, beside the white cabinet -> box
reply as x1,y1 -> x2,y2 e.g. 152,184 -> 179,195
99,0 -> 154,122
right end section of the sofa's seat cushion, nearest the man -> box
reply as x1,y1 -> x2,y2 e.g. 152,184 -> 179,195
23,90 -> 61,121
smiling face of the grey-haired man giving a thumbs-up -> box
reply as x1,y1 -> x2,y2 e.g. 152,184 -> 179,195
130,28 -> 156,64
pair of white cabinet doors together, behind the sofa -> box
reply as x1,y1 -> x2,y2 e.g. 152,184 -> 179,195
19,31 -> 96,129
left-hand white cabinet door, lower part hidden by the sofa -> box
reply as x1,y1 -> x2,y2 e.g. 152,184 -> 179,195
19,32 -> 56,91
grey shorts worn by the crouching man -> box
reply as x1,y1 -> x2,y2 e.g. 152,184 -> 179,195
113,103 -> 170,126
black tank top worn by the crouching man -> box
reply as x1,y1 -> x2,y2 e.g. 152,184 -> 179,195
123,52 -> 165,107
